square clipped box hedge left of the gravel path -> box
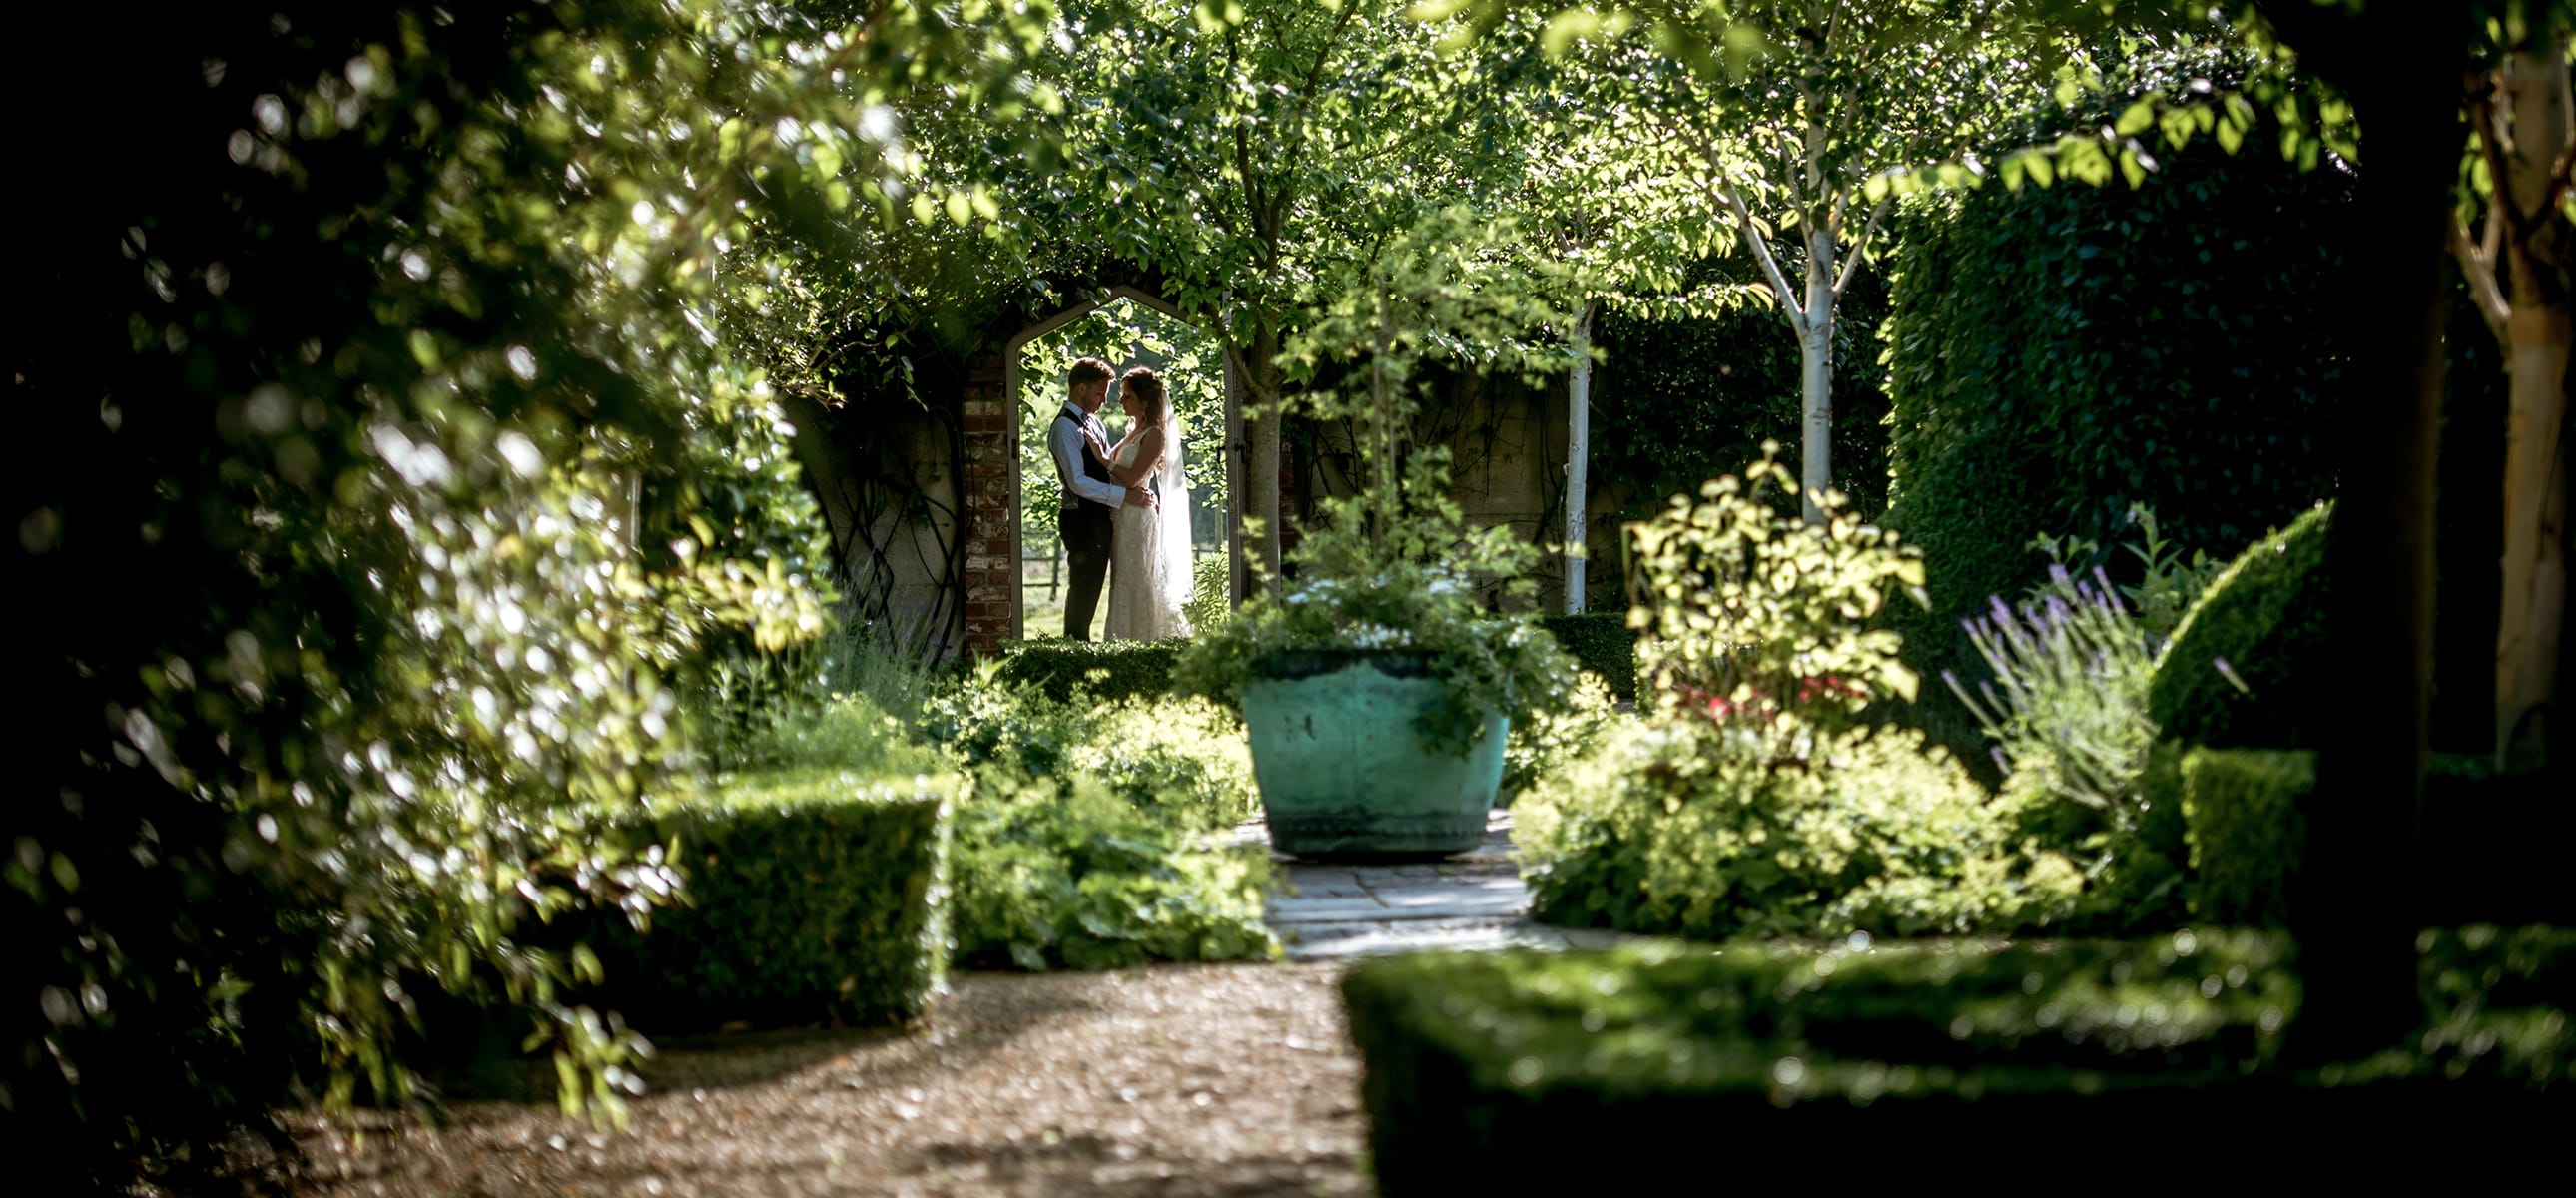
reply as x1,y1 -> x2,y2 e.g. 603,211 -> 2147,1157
592,768 -> 956,1033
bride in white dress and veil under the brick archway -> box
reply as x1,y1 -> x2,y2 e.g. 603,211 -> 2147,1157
1102,365 -> 1193,642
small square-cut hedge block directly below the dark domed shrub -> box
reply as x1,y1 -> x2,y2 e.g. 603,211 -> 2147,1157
2182,750 -> 2315,927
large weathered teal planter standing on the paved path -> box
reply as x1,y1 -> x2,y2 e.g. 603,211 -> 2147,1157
1244,657 -> 1512,858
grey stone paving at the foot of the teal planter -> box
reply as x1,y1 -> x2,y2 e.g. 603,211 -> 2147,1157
1242,809 -> 1608,961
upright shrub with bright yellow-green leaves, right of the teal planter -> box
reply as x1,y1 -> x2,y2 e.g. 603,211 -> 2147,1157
1628,443 -> 1924,758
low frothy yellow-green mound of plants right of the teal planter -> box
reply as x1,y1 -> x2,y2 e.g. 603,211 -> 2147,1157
1515,722 -> 2082,940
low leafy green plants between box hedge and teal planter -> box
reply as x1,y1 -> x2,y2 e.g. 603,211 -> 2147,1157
956,765 -> 1280,968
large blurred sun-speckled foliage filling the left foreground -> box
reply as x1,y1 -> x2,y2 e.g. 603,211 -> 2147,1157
0,0 -> 1055,1185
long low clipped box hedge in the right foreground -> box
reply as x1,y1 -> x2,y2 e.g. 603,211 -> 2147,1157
1342,932 -> 2568,1198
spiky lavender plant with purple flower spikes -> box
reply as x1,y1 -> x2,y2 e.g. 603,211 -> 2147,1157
1942,567 -> 2156,830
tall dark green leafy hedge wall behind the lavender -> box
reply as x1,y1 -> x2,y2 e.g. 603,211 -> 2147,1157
1880,41 -> 2352,750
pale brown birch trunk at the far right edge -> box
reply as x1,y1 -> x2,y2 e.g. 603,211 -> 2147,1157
2493,36 -> 2571,771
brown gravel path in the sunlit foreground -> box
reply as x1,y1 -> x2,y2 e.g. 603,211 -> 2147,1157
279,963 -> 1368,1195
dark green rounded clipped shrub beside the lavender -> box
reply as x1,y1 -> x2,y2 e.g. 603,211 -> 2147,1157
2149,505 -> 2333,750
